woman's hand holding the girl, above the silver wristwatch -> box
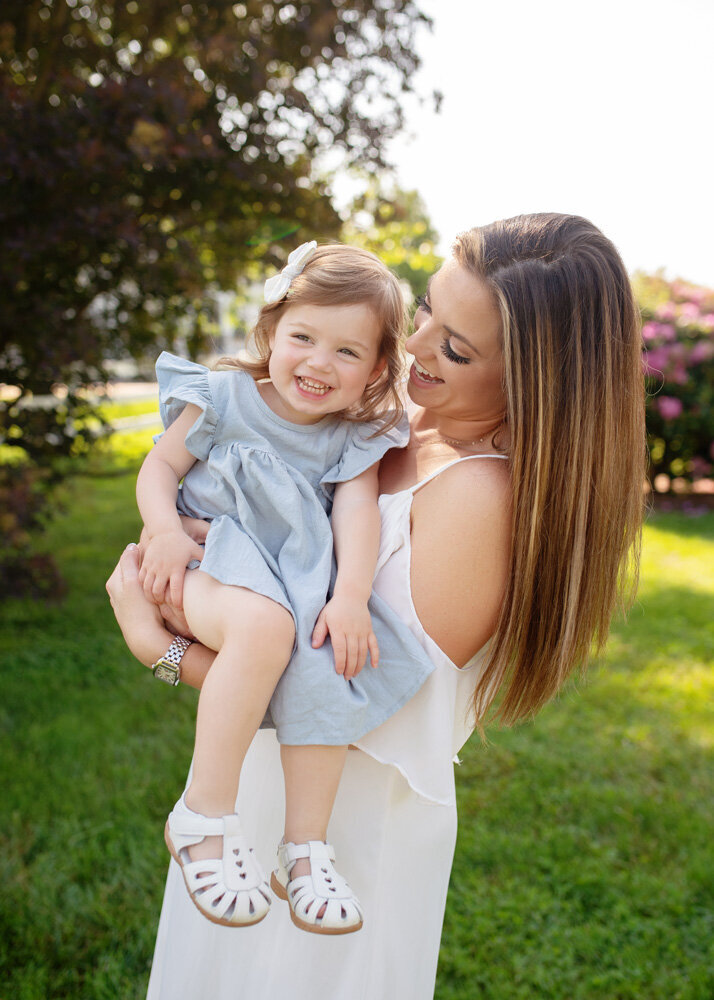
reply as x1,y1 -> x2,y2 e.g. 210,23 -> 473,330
106,543 -> 177,667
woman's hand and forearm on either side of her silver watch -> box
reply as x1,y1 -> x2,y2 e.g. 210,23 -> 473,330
106,544 -> 216,688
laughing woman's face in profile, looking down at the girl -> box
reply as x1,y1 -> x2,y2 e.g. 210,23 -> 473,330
406,260 -> 506,421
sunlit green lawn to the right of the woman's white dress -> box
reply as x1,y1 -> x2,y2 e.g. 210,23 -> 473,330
444,514 -> 714,1000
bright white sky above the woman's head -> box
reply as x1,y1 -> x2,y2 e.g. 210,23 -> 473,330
391,0 -> 714,287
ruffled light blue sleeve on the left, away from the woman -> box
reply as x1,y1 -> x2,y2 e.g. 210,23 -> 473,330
156,351 -> 218,461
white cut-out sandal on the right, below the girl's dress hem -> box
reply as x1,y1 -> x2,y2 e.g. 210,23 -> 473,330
270,840 -> 362,934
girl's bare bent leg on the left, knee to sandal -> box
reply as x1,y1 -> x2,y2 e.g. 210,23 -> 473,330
184,571 -> 298,860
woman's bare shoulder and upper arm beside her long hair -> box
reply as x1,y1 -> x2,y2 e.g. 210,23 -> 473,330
404,458 -> 511,667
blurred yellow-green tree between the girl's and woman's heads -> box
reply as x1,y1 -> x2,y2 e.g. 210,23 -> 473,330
342,180 -> 442,297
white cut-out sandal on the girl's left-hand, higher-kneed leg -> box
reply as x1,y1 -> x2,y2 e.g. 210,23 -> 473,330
164,795 -> 271,927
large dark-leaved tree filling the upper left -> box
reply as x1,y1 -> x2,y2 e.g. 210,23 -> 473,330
0,0 -> 427,458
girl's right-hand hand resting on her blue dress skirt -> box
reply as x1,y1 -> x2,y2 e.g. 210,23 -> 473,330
312,594 -> 379,680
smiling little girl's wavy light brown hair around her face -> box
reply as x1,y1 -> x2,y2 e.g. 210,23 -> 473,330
225,243 -> 407,434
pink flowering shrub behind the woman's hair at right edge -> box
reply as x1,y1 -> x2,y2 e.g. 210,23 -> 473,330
634,274 -> 714,479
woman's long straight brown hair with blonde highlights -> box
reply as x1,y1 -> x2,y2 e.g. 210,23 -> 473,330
454,214 -> 646,724
